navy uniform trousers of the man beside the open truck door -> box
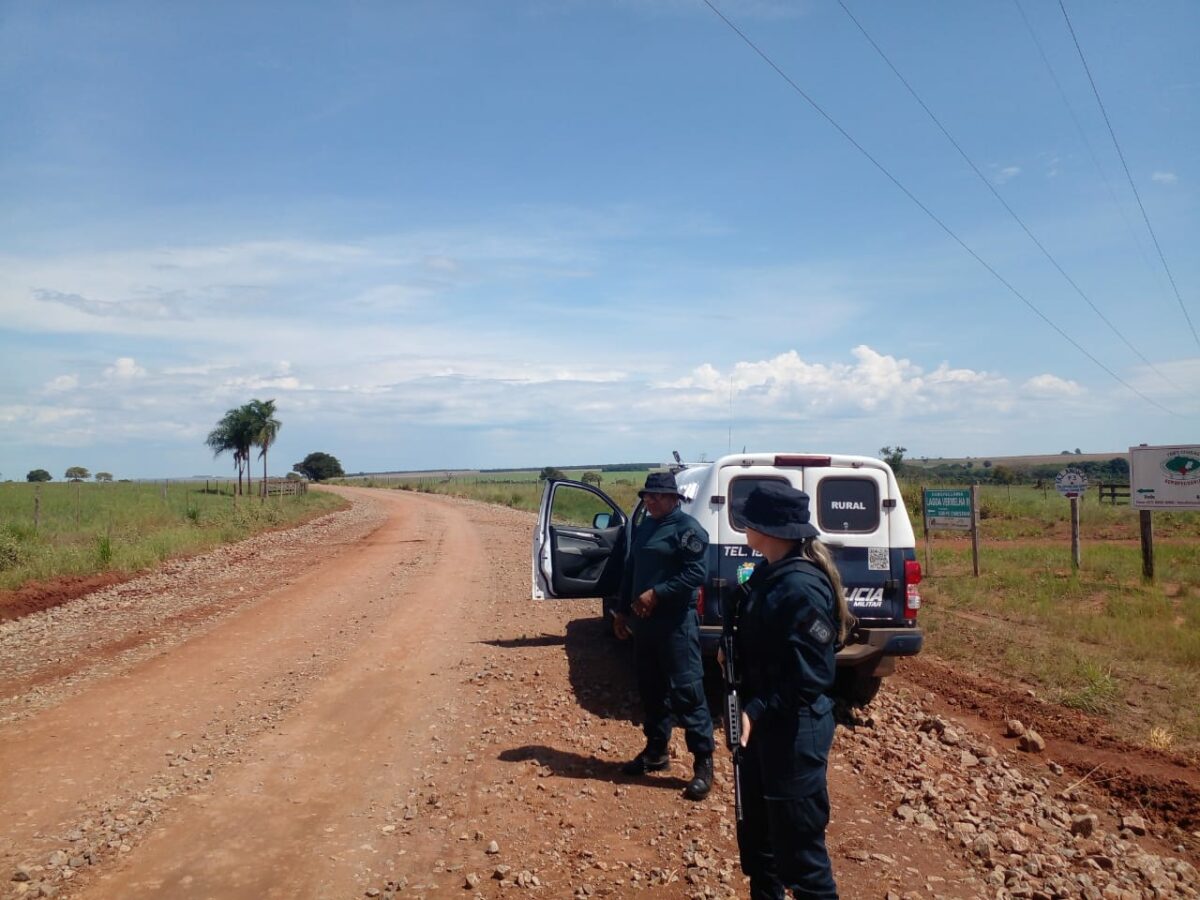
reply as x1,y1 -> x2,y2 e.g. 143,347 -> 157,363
634,607 -> 715,756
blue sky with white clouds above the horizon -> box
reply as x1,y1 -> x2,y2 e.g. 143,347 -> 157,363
0,0 -> 1200,479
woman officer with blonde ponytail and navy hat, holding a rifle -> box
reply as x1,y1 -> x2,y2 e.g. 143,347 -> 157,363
728,481 -> 853,900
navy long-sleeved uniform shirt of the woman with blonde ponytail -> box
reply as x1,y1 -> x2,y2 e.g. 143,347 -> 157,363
738,557 -> 838,725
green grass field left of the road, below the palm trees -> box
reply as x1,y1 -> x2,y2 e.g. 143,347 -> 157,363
0,481 -> 346,589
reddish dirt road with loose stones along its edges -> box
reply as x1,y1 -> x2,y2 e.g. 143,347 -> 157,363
0,488 -> 1200,898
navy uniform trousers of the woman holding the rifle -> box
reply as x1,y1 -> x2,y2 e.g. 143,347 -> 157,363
738,697 -> 838,900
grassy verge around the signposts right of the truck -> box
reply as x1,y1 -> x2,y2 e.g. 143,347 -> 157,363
922,542 -> 1200,754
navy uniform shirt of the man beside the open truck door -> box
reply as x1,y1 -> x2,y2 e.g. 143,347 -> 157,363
620,506 -> 708,622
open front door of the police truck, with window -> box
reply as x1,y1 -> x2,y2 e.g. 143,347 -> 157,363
533,481 -> 629,600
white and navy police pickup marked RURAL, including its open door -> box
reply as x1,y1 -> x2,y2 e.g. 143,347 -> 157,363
533,452 -> 924,706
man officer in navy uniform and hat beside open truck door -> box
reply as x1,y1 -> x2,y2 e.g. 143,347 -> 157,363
613,472 -> 714,800
